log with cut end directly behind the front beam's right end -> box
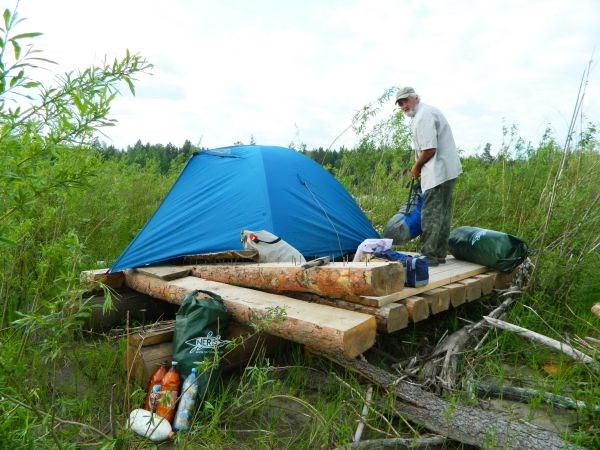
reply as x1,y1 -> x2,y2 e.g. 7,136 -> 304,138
284,292 -> 408,333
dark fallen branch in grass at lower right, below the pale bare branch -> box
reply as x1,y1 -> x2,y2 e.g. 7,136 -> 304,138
468,381 -> 600,413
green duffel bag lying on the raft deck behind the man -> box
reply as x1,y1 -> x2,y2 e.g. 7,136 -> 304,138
448,227 -> 529,272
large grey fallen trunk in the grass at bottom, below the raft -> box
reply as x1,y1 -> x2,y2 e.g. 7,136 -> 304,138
324,355 -> 576,450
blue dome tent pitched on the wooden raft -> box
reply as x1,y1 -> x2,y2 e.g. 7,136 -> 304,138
110,145 -> 379,272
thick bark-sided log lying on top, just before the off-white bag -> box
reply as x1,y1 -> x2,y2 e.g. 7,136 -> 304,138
191,262 -> 404,306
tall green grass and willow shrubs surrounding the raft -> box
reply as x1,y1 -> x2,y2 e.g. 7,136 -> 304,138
0,4 -> 600,448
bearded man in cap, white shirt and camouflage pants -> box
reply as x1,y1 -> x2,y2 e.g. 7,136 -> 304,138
396,86 -> 462,266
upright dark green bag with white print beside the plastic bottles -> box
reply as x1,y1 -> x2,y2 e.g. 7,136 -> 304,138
173,290 -> 229,398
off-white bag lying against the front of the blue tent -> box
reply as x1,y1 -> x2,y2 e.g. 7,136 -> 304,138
241,230 -> 306,264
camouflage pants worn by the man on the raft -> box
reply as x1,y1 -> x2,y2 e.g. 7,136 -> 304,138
421,178 -> 456,258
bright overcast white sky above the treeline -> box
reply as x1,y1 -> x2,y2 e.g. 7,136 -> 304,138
15,0 -> 600,153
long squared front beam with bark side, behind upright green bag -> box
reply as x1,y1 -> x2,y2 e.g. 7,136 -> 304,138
125,270 -> 376,357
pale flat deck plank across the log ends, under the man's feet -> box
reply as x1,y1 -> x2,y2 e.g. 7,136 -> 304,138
363,258 -> 489,306
